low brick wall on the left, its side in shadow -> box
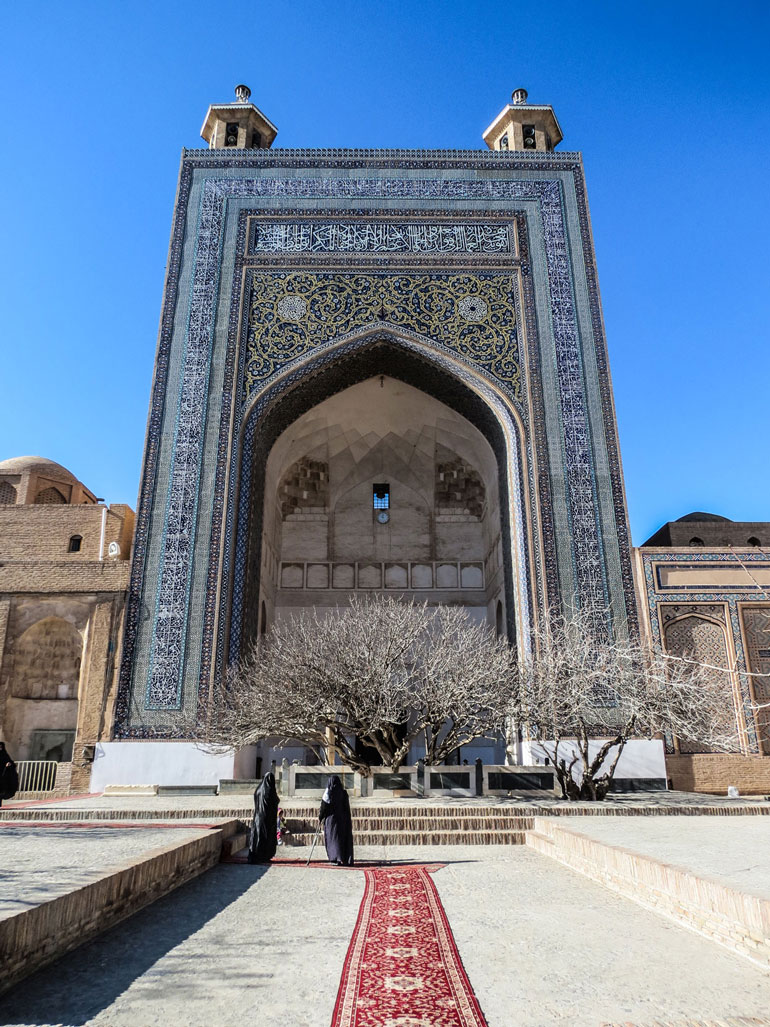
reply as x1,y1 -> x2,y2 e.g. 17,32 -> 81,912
0,821 -> 238,993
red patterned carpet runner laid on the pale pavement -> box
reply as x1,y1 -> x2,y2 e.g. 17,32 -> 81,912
332,866 -> 487,1027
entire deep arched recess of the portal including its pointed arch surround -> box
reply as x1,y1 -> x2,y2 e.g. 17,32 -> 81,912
229,334 -> 531,659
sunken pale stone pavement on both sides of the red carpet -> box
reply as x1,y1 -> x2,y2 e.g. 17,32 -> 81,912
0,842 -> 770,1027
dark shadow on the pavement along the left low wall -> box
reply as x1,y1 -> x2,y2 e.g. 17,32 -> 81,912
0,866 -> 269,1027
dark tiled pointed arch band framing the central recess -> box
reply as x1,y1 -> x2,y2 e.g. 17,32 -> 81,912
223,325 -> 537,659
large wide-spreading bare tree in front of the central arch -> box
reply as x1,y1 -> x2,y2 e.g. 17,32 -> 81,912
203,595 -> 513,774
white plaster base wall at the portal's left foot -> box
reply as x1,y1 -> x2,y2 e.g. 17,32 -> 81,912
90,741 -> 235,792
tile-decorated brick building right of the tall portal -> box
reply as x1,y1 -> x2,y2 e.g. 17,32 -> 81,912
636,512 -> 770,795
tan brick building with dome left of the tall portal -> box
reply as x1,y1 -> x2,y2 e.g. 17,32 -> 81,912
0,456 -> 133,792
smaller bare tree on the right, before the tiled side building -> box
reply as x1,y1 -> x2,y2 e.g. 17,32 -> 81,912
511,611 -> 740,800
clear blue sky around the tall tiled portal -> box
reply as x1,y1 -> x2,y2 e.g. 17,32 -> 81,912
0,0 -> 770,543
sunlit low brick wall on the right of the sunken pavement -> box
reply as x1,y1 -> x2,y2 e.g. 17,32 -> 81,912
527,816 -> 770,969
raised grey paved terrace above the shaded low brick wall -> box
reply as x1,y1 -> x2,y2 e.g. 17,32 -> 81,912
0,824 -> 206,919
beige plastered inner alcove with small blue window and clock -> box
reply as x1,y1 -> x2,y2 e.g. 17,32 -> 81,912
260,375 -> 504,619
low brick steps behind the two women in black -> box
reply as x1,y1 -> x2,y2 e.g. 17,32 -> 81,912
284,806 -> 533,846
